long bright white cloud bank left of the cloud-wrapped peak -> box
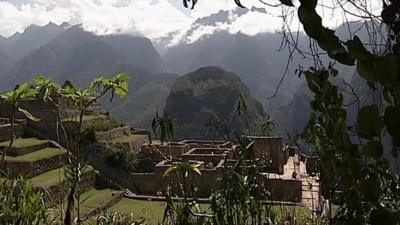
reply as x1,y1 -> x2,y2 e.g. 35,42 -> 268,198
0,0 -> 192,38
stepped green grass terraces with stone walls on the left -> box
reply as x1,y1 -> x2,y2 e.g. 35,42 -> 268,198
0,103 -> 148,220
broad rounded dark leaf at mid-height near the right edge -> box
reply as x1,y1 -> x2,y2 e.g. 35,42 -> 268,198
357,105 -> 384,139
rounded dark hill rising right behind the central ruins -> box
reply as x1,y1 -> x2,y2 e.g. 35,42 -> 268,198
166,67 -> 265,139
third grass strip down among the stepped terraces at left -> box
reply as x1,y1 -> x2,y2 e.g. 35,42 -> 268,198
30,166 -> 93,187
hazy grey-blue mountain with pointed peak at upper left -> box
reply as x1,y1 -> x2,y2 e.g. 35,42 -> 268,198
1,26 -> 126,86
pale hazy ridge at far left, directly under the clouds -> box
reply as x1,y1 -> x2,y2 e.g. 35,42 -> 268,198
0,23 -> 70,60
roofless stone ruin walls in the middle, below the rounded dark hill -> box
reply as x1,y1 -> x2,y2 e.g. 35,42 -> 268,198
131,136 -> 307,202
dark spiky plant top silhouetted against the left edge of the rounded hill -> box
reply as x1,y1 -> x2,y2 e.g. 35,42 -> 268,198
151,109 -> 175,143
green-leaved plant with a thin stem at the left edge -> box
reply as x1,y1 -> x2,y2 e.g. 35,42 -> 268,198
0,83 -> 39,162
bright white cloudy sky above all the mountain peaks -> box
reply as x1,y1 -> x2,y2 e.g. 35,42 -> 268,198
0,0 -> 380,42
